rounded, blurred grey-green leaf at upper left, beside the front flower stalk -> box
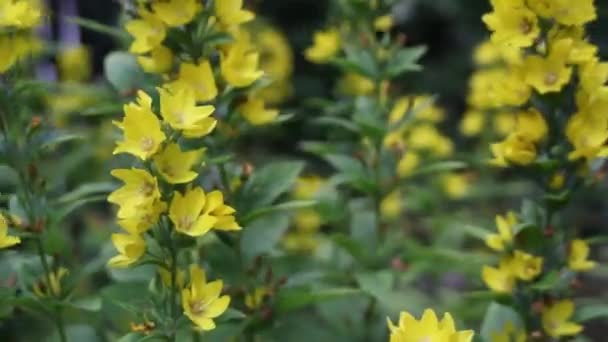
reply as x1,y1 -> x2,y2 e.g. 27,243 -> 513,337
104,51 -> 145,93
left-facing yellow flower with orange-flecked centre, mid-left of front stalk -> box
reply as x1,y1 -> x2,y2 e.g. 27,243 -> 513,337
108,168 -> 160,218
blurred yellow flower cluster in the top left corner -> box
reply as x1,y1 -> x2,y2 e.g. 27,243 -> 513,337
0,0 -> 44,73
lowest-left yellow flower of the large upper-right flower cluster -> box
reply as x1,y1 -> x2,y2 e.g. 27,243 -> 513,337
490,132 -> 536,167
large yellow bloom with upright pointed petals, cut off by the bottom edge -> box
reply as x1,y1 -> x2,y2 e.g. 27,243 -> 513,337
387,309 -> 474,342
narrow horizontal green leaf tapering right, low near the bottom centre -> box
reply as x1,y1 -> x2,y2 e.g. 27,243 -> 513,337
276,287 -> 361,314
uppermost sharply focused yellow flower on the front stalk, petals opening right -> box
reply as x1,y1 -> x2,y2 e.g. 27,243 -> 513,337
158,87 -> 217,138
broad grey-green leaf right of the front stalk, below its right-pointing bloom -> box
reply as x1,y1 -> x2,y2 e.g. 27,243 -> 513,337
241,212 -> 289,260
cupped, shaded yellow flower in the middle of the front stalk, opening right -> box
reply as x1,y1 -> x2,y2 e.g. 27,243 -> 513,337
154,143 -> 204,184
